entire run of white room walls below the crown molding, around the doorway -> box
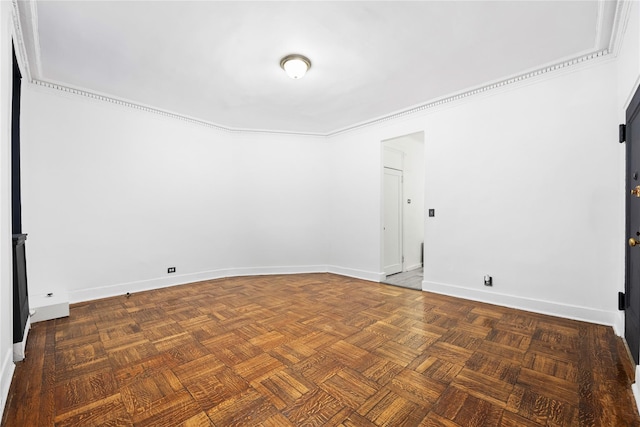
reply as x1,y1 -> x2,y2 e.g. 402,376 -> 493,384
12,1 -> 635,334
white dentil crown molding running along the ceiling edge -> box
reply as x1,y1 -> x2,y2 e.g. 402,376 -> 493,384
12,0 -> 631,137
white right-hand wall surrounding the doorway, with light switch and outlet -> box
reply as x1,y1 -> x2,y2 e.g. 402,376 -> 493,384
330,60 -> 624,323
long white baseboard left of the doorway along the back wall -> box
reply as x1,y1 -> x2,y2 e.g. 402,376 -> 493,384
69,265 -> 340,303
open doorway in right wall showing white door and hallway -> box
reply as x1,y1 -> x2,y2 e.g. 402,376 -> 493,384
381,132 -> 425,289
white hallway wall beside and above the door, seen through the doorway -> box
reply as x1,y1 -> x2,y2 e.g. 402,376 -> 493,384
384,132 -> 425,271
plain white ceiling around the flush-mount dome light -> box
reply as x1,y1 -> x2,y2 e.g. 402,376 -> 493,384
13,0 -> 616,134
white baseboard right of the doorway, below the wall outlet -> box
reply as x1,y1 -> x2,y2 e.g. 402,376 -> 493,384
422,280 -> 617,327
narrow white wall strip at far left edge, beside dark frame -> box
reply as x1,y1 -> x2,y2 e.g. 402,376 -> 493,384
0,1 -> 15,414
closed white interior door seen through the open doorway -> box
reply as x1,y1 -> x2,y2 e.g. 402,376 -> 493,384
382,168 -> 403,276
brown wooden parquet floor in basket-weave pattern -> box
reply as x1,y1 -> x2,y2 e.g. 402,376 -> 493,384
2,274 -> 640,427
